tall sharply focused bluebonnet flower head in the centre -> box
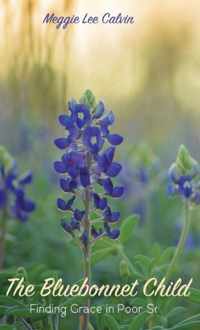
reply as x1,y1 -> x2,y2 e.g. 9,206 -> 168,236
54,91 -> 124,244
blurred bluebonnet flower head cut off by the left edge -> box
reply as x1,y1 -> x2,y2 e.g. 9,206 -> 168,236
0,146 -> 35,222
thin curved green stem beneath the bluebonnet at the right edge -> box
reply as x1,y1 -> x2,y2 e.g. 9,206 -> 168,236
165,202 -> 191,279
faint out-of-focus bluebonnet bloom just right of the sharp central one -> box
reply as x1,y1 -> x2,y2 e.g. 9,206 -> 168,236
120,143 -> 161,223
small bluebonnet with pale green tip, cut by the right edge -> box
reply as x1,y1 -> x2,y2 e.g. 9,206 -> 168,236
168,146 -> 200,205
